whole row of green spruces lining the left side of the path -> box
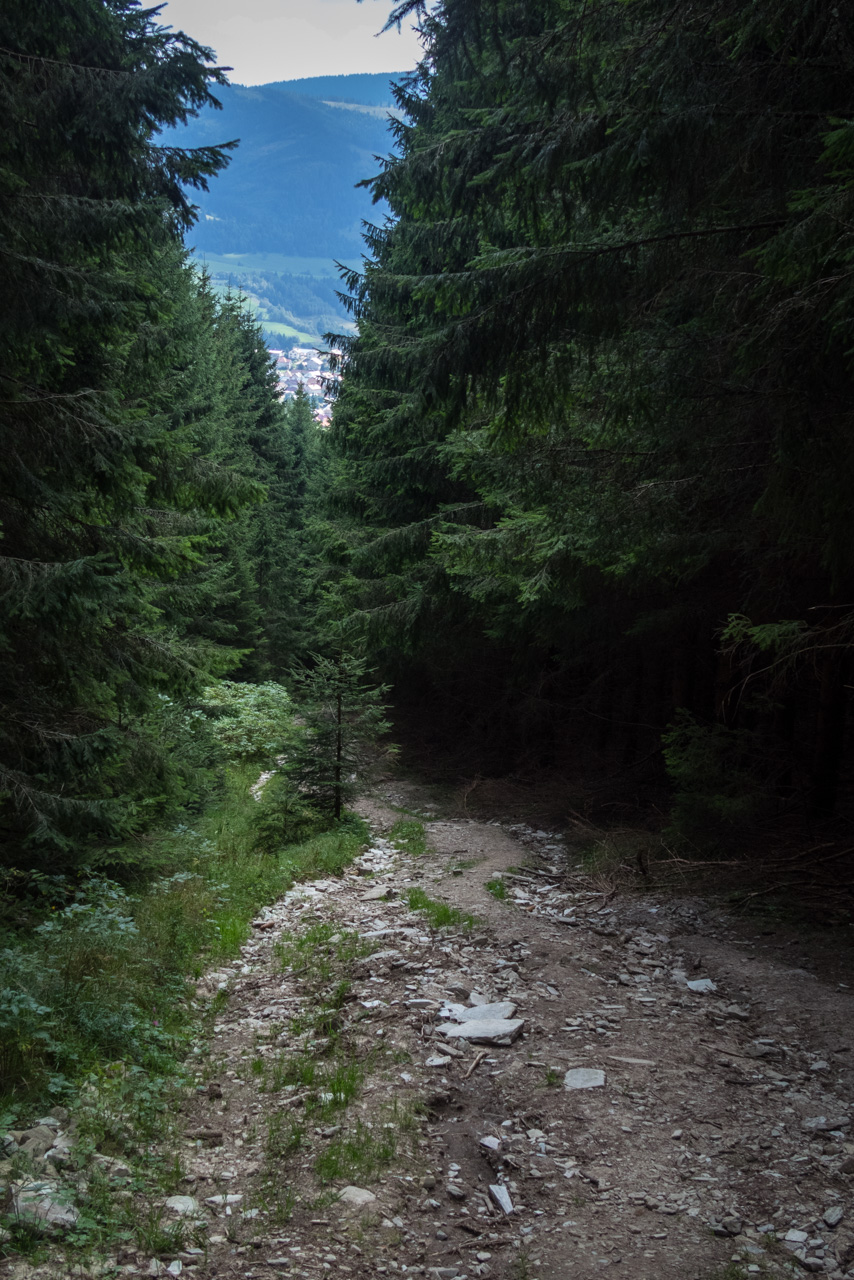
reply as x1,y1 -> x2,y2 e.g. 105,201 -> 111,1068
0,0 -> 338,869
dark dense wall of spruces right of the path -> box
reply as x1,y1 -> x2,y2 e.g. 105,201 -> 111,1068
335,0 -> 854,847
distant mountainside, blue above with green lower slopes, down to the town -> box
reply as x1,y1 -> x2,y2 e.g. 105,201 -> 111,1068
174,73 -> 402,340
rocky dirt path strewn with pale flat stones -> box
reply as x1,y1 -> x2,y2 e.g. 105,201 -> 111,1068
6,785 -> 854,1280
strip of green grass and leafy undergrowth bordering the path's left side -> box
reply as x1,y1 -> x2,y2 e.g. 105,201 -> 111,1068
0,769 -> 366,1124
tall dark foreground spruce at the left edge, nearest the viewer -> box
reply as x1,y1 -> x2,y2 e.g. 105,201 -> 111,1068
0,0 -> 248,861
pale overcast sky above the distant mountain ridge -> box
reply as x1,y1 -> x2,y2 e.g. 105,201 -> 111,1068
160,0 -> 419,84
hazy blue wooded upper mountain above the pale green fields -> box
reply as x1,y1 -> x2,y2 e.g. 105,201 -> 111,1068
179,77 -> 399,257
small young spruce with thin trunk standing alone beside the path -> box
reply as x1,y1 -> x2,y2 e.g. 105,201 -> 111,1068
288,653 -> 394,819
